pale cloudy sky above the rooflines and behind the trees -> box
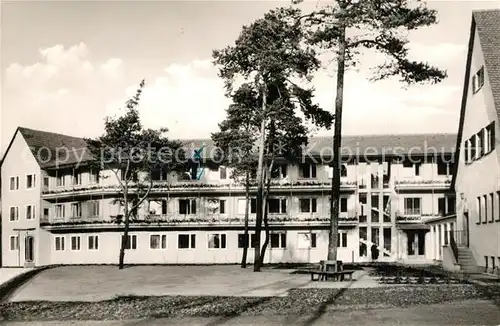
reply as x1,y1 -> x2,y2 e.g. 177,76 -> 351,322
0,0 -> 500,153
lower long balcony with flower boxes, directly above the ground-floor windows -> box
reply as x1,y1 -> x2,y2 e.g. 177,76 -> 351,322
40,213 -> 358,230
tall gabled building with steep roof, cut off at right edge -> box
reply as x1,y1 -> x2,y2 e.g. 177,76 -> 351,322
453,10 -> 500,273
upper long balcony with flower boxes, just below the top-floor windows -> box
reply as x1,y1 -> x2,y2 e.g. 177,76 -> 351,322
42,180 -> 356,199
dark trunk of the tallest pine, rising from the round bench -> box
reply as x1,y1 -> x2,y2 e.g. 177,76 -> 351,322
328,22 -> 347,269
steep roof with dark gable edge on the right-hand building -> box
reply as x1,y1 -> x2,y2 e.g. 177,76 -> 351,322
451,10 -> 500,188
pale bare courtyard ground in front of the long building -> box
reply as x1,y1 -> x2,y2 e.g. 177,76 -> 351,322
10,266 -> 379,301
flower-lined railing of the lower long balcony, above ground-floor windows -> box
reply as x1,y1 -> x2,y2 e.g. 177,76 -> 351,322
40,214 -> 358,227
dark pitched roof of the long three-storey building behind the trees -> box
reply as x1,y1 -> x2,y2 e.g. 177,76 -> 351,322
1,127 -> 456,168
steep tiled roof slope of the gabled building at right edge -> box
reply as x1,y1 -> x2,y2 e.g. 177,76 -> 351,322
472,9 -> 500,121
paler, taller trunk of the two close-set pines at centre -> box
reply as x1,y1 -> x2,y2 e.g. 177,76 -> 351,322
253,80 -> 267,272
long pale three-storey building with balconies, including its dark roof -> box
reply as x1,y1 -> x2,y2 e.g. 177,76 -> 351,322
1,128 -> 456,266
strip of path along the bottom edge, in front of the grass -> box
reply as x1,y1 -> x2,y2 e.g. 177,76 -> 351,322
6,300 -> 500,326
